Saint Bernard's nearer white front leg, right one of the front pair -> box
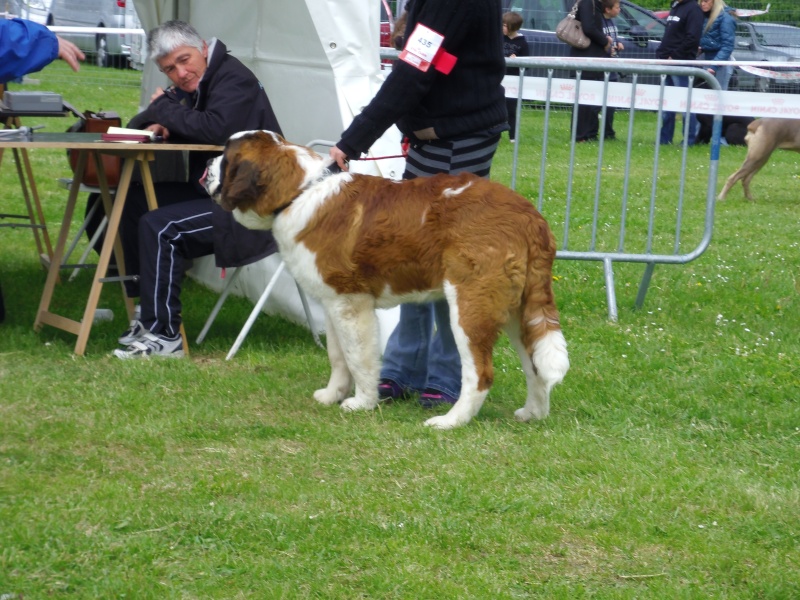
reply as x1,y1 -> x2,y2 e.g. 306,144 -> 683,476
326,294 -> 381,410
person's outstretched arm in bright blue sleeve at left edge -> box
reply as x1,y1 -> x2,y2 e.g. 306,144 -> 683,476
0,19 -> 86,323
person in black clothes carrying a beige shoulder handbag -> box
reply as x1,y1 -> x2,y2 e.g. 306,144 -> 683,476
569,0 -> 611,142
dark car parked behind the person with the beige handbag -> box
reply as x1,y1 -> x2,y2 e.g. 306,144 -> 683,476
503,0 -> 665,83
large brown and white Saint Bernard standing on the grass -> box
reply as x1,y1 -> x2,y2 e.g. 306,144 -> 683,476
202,131 -> 569,429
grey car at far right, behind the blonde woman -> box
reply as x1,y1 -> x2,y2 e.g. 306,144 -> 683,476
729,21 -> 800,94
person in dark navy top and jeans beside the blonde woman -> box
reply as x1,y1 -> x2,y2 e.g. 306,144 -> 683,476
656,0 -> 703,146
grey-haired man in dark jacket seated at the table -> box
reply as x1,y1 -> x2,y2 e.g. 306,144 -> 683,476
114,21 -> 280,359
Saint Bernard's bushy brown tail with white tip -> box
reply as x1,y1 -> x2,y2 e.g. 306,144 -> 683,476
520,216 -> 569,384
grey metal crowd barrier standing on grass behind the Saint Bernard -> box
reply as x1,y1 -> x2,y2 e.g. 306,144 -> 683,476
506,59 -> 722,321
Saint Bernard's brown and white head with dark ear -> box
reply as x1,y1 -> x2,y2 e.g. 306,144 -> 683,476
201,131 -> 310,229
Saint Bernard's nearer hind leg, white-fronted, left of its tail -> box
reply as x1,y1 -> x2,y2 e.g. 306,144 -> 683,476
425,281 -> 500,429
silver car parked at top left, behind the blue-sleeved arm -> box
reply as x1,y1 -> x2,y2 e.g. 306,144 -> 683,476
18,0 -> 138,67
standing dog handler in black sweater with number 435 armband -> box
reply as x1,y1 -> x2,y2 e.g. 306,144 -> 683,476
330,0 -> 508,407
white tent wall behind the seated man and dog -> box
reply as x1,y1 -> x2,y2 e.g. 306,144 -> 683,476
134,0 -> 403,347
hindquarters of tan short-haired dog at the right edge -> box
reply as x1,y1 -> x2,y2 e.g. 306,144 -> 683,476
717,118 -> 800,200
